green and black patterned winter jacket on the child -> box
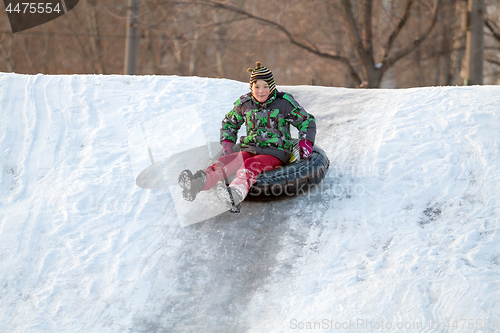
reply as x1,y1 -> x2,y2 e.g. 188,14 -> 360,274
220,92 -> 316,163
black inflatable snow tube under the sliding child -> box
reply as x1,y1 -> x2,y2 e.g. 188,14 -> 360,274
207,139 -> 330,197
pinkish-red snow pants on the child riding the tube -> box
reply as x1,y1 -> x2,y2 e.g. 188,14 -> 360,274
203,151 -> 283,197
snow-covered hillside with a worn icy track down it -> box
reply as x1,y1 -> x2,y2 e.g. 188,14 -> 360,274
0,74 -> 500,332
